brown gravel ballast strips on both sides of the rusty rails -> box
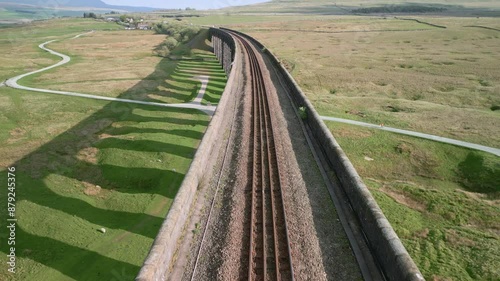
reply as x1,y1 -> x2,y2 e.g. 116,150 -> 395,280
174,31 -> 362,280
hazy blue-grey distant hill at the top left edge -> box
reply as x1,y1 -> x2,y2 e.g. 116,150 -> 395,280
0,0 -> 155,12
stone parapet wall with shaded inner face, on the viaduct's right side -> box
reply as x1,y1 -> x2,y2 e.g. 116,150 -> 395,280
224,26 -> 424,281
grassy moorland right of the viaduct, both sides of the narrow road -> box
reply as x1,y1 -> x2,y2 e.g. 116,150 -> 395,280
220,7 -> 500,280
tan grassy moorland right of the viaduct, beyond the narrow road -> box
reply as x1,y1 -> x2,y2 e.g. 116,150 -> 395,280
239,17 -> 500,147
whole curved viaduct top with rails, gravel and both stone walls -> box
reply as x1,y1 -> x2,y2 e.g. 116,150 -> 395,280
137,26 -> 423,281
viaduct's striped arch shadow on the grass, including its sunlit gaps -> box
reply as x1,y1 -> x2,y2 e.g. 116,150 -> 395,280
0,30 -> 225,280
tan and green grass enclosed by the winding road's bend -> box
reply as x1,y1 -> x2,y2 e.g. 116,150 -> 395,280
15,30 -> 226,103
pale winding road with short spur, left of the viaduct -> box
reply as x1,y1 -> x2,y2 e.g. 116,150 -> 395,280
5,31 -> 216,116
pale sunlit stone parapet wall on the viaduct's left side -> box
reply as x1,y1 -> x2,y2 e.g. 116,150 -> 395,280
135,29 -> 238,281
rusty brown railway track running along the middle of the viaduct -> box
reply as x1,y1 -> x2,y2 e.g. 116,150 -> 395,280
232,30 -> 294,280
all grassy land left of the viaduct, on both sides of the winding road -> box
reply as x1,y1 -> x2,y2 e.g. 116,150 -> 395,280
0,19 -> 225,280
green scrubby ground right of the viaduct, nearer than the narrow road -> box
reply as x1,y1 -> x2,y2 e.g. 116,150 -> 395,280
327,122 -> 500,280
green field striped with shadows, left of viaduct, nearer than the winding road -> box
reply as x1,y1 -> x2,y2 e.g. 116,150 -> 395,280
0,86 -> 208,280
